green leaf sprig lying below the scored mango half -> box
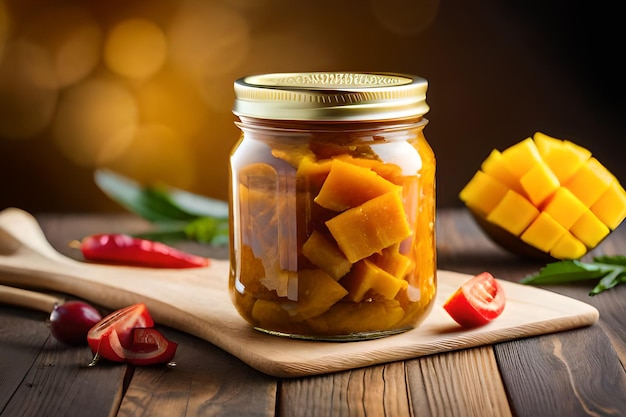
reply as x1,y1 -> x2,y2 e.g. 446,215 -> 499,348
520,255 -> 626,295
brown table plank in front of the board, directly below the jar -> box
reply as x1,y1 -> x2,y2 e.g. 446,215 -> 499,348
277,362 -> 411,417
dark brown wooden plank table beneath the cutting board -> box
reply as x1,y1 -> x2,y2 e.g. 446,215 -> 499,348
0,209 -> 626,417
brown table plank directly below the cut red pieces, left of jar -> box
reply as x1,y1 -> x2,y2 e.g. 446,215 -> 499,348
117,328 -> 277,417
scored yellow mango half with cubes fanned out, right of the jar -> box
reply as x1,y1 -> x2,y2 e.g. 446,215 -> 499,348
459,132 -> 626,259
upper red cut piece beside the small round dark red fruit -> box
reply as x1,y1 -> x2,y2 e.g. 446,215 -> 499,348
87,303 -> 154,357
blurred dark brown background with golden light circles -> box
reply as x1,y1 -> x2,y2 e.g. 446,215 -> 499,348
0,0 -> 626,212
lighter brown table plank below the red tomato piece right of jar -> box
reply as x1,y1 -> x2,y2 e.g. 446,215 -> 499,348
406,346 -> 512,417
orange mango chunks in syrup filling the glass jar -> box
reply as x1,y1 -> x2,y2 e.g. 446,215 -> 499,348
231,143 -> 436,336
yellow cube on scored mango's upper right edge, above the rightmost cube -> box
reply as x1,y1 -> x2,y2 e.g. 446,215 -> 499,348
564,158 -> 615,207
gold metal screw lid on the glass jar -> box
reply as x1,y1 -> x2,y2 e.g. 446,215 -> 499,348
233,72 -> 429,121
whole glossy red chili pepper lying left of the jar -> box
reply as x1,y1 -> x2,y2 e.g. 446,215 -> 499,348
78,233 -> 209,268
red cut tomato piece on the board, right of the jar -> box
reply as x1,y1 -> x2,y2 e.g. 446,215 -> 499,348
443,272 -> 506,327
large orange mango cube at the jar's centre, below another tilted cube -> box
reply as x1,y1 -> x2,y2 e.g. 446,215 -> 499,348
326,191 -> 412,263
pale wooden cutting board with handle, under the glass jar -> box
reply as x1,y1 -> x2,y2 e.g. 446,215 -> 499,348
0,208 -> 599,377
